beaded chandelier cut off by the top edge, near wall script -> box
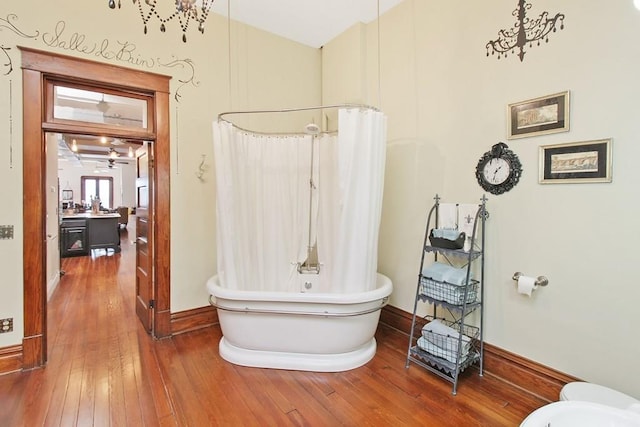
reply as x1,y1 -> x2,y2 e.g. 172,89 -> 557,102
109,0 -> 214,43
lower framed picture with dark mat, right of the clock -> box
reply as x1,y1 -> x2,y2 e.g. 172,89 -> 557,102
539,139 -> 611,184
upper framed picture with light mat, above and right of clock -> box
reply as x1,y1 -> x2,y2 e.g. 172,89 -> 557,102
507,91 -> 569,139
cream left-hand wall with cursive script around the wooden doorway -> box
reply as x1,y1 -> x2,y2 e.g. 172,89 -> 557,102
0,0 -> 321,348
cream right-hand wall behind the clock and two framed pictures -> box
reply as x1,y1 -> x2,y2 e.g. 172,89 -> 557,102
323,0 -> 640,398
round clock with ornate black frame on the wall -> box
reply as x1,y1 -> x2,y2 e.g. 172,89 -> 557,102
476,142 -> 522,194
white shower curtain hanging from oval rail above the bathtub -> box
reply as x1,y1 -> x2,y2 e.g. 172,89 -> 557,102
213,108 -> 386,292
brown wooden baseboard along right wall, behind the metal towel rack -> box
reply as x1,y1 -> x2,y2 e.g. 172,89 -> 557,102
380,305 -> 581,402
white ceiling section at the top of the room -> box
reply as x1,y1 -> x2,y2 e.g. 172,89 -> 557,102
209,0 -> 402,48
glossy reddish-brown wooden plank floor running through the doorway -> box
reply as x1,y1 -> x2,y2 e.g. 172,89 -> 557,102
0,221 -> 544,427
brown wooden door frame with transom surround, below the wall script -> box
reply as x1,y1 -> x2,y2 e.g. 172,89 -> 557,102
18,46 -> 171,369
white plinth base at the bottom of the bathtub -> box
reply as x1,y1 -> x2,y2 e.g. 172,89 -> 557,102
219,337 -> 376,372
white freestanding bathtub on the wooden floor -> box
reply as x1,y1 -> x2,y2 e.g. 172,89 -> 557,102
207,274 -> 393,372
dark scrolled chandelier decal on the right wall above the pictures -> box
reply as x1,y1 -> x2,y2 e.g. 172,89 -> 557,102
486,0 -> 564,62
